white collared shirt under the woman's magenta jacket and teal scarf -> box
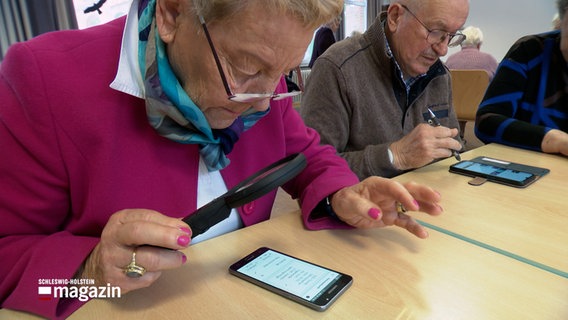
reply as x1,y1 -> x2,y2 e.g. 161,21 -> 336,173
110,0 -> 243,244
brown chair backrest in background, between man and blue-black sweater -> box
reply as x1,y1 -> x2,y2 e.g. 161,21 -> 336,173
450,69 -> 489,121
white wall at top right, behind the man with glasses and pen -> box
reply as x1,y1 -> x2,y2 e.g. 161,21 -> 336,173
442,0 -> 557,61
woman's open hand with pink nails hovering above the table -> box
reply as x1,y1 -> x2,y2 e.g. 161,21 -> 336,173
331,177 -> 443,238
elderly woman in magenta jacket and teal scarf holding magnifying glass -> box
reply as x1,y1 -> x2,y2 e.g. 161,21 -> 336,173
0,0 -> 442,318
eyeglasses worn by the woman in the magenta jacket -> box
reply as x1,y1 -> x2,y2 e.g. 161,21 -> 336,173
199,16 -> 302,103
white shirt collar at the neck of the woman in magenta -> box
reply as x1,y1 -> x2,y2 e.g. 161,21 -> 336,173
110,0 -> 145,99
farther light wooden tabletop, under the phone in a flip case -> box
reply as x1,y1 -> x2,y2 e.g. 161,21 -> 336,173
395,144 -> 568,275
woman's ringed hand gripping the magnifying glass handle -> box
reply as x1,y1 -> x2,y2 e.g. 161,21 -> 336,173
81,209 -> 191,294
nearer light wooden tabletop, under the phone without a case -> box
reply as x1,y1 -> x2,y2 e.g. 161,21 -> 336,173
50,214 -> 568,319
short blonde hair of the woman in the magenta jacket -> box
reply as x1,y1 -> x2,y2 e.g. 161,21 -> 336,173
192,0 -> 343,28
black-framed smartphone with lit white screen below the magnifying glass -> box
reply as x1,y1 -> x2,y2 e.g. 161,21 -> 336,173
229,247 -> 353,311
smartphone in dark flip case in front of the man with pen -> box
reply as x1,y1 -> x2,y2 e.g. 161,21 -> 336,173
450,157 -> 549,188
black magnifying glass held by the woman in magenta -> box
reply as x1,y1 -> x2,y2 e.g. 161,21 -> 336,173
183,153 -> 306,238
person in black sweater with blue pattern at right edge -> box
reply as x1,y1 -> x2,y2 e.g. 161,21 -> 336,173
475,0 -> 568,156
